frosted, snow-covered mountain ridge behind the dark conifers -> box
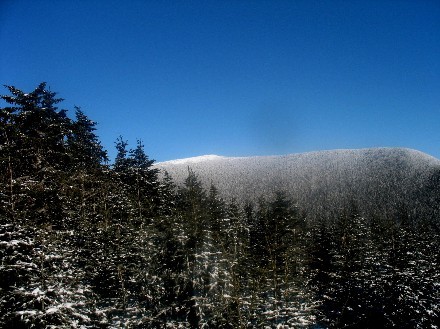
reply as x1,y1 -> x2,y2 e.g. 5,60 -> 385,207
156,148 -> 440,220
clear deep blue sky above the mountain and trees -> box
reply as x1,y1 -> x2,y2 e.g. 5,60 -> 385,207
0,0 -> 440,161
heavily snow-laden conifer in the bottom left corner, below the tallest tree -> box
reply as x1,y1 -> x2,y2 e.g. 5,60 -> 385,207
0,219 -> 99,328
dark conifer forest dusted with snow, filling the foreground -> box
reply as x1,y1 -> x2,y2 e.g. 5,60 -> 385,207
0,83 -> 440,328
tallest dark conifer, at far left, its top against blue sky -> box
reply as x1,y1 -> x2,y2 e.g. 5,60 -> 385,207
2,83 -> 71,225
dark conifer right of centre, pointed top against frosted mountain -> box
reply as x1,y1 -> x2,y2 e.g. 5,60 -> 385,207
246,192 -> 314,327
